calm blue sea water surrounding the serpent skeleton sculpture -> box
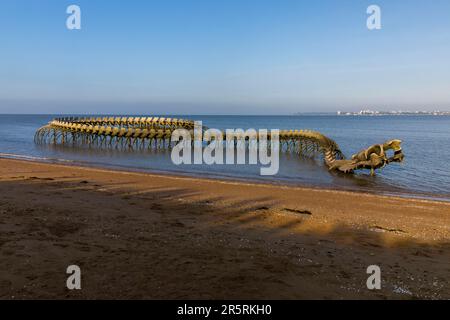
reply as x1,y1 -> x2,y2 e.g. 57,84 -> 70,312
0,115 -> 450,199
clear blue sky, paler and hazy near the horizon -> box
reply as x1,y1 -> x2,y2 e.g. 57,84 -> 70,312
0,0 -> 450,114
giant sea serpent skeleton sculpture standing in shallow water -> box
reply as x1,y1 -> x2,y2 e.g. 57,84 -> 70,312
34,117 -> 404,175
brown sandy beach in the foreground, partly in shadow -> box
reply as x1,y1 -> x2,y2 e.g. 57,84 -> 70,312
0,159 -> 450,299
